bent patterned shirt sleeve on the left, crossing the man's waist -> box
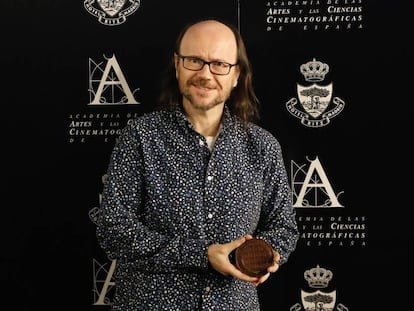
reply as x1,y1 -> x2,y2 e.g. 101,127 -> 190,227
96,126 -> 209,272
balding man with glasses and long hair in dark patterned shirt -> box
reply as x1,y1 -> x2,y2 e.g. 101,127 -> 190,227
97,20 -> 298,311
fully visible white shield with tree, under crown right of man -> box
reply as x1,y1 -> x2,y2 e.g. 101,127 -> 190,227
297,83 -> 333,118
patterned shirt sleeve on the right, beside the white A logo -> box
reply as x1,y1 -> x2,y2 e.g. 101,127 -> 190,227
255,132 -> 299,264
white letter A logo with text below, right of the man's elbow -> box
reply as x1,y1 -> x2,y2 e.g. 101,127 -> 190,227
291,157 -> 367,247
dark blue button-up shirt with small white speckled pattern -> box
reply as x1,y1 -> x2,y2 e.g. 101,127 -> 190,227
97,107 -> 298,311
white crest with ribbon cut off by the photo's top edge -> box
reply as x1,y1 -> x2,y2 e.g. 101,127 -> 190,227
83,0 -> 141,26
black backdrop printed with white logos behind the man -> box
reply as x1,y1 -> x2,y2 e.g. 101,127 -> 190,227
0,0 -> 413,310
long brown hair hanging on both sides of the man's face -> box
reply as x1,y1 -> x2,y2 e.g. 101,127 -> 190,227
157,18 -> 259,123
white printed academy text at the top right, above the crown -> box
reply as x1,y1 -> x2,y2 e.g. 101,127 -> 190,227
265,0 -> 365,32
